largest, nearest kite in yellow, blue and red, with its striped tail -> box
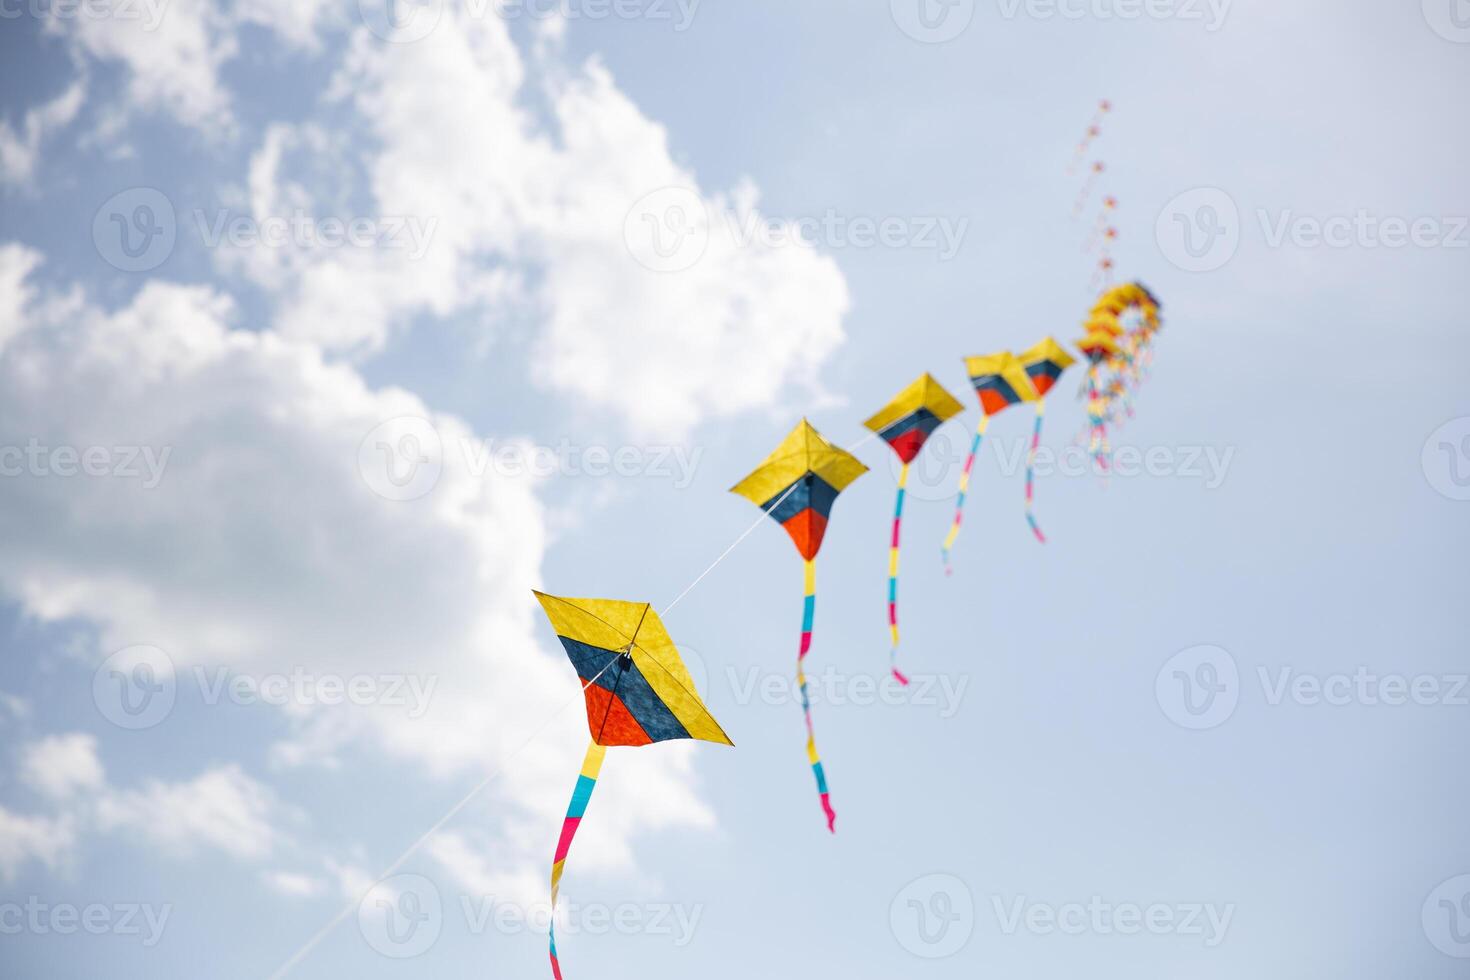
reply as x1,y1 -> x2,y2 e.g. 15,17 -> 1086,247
535,592 -> 734,980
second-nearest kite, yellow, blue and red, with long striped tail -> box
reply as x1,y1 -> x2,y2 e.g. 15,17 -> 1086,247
731,419 -> 867,833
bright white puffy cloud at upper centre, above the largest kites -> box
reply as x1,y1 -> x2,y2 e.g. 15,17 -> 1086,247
232,7 -> 848,436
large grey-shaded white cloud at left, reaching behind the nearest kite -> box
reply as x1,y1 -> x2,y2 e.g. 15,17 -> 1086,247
0,251 -> 710,905
